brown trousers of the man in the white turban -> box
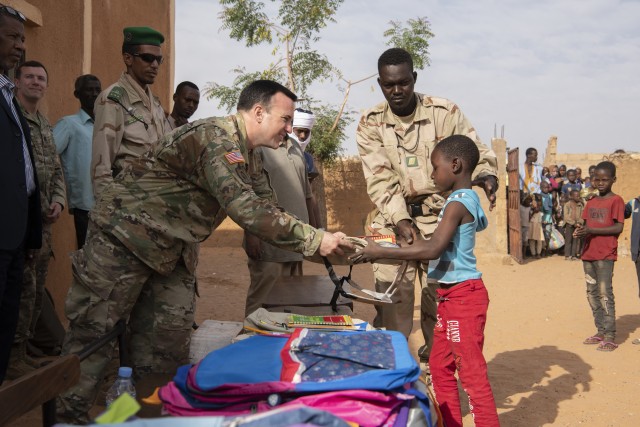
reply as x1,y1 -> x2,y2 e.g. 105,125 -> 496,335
244,258 -> 302,317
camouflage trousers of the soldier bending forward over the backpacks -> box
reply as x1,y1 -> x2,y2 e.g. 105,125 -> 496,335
58,222 -> 195,422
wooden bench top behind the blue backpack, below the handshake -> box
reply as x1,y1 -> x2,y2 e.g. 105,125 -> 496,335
262,276 -> 353,315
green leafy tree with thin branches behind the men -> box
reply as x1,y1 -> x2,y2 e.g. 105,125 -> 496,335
205,0 -> 433,162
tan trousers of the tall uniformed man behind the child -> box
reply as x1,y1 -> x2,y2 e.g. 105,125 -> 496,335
365,209 -> 438,360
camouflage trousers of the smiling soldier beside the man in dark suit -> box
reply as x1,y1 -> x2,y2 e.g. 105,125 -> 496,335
13,224 -> 53,344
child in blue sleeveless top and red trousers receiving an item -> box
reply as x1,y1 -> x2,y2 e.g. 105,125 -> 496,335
351,135 -> 500,426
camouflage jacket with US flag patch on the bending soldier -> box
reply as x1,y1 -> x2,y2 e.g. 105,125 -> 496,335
91,114 -> 323,274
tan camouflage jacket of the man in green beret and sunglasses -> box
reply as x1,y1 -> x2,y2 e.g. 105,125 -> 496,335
91,73 -> 169,197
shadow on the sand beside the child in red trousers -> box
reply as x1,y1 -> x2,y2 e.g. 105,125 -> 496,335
488,346 -> 592,427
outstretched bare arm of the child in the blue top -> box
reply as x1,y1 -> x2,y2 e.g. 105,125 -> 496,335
350,203 -> 473,262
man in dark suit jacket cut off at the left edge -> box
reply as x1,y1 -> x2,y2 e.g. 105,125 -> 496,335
0,6 -> 42,384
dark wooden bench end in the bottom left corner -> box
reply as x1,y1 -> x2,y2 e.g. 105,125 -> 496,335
0,354 -> 80,427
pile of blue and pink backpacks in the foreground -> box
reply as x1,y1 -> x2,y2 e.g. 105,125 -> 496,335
158,328 -> 437,427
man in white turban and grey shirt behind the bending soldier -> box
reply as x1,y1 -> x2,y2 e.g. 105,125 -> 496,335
244,109 -> 319,316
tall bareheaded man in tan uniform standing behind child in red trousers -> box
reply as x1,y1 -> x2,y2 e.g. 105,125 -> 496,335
356,48 -> 497,362
